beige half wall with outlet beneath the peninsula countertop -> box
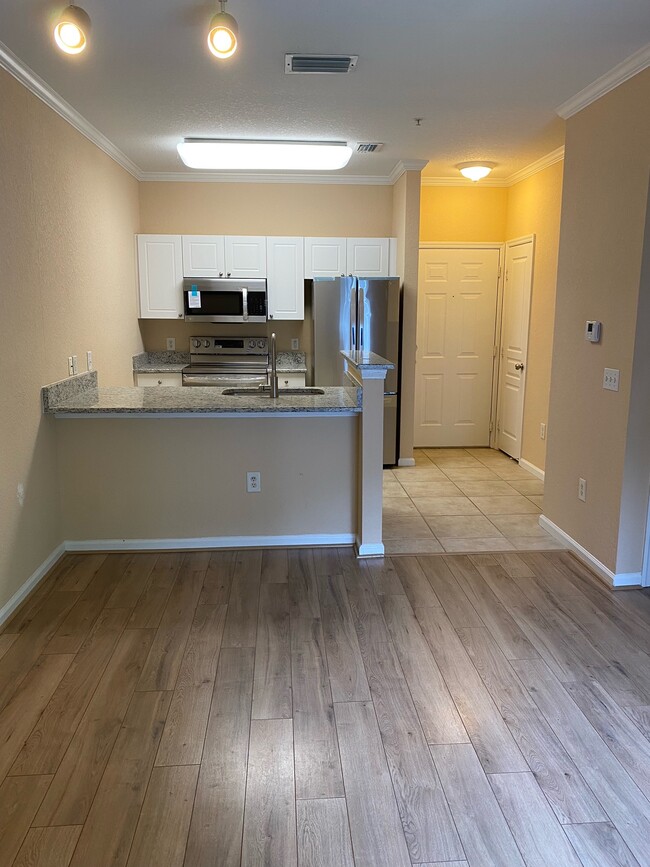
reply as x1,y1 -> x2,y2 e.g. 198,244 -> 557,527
56,416 -> 359,540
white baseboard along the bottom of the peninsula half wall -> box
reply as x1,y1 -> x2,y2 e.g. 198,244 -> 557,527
65,533 -> 356,551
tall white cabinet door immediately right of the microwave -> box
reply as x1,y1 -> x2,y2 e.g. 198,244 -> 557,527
266,238 -> 305,319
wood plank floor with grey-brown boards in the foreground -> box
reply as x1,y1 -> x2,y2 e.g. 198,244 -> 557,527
0,549 -> 650,867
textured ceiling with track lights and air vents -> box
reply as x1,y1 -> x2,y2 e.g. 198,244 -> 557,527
0,0 -> 650,178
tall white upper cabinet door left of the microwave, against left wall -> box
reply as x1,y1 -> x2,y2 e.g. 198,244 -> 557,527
137,235 -> 183,319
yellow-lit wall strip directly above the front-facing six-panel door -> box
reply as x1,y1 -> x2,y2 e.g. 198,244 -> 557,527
420,183 -> 509,243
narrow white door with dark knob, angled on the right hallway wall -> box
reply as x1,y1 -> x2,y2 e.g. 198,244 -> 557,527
497,237 -> 534,460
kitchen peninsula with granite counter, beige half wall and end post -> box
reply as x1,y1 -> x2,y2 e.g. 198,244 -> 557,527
43,353 -> 391,556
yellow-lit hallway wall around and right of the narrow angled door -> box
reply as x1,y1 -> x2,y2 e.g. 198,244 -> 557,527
506,162 -> 563,470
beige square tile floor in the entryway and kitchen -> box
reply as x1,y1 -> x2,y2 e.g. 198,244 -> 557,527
383,449 -> 563,554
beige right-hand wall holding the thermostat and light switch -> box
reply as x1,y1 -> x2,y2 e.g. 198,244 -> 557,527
544,70 -> 650,572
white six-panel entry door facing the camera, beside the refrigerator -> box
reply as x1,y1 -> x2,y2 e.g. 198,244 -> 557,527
415,248 -> 499,448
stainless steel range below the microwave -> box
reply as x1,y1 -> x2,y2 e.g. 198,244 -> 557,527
183,337 -> 269,388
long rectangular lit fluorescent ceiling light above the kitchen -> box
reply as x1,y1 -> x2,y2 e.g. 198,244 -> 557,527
178,138 -> 352,171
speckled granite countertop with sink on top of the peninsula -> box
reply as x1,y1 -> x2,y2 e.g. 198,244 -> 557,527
42,371 -> 361,418
